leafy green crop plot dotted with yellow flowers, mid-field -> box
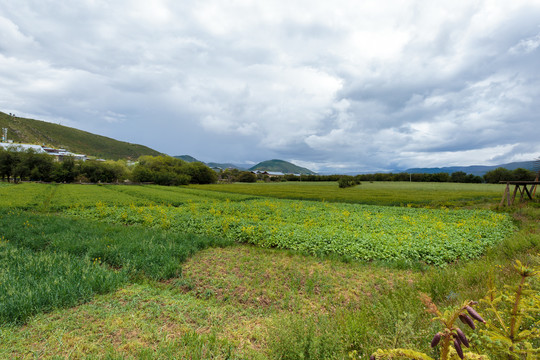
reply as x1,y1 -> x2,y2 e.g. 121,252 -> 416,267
68,199 -> 514,265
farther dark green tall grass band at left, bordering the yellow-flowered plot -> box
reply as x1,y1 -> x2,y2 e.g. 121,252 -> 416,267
0,210 -> 231,280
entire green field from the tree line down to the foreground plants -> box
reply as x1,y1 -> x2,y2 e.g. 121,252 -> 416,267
0,183 -> 540,359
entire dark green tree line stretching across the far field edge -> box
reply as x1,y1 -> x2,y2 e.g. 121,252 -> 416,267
0,148 -> 537,187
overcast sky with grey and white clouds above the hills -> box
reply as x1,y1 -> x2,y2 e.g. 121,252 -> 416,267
0,0 -> 540,172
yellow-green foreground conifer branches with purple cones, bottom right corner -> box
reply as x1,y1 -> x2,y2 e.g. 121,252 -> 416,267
370,260 -> 540,360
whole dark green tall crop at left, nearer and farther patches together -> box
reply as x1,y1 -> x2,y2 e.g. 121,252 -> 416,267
0,210 -> 229,324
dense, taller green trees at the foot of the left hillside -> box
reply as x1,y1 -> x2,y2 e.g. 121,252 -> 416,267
0,149 -> 217,185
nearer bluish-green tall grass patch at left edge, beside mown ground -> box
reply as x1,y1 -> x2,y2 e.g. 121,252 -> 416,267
0,241 -> 127,324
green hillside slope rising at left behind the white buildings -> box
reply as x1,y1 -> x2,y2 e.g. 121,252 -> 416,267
0,112 -> 160,160
